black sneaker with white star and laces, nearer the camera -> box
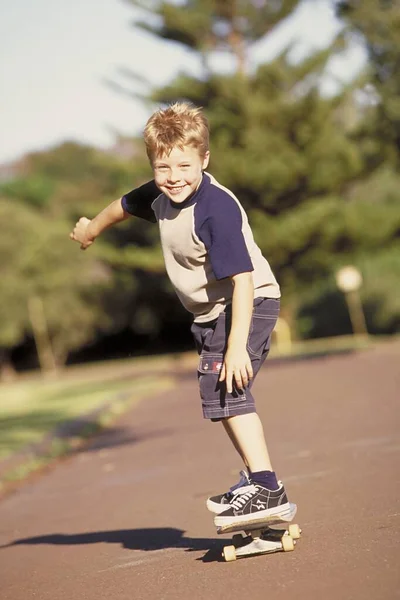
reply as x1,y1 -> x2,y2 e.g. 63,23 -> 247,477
214,481 -> 291,527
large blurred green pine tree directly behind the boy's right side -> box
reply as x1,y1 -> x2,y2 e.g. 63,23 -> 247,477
122,0 -> 399,332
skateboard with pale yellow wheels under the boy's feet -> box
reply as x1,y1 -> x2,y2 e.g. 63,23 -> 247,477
217,504 -> 301,562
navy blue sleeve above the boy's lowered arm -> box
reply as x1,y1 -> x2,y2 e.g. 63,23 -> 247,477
196,193 -> 253,279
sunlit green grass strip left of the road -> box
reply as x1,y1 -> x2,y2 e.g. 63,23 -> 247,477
0,371 -> 171,460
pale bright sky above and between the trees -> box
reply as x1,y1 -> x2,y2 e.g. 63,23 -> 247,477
0,0 -> 366,164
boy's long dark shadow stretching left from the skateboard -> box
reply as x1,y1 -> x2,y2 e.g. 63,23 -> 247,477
0,527 -> 224,562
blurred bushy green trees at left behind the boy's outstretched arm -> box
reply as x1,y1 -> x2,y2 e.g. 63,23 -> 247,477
0,142 -> 177,370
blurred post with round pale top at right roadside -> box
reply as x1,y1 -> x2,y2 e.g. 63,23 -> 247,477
336,265 -> 368,335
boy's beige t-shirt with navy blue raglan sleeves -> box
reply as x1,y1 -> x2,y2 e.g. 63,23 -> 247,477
122,173 -> 280,323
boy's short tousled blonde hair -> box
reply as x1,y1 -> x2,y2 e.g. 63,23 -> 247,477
143,102 -> 209,162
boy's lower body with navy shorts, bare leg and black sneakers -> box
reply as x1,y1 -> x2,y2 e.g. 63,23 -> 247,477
192,298 -> 288,525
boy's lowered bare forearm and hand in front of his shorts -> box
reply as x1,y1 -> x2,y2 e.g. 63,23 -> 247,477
219,272 -> 254,393
